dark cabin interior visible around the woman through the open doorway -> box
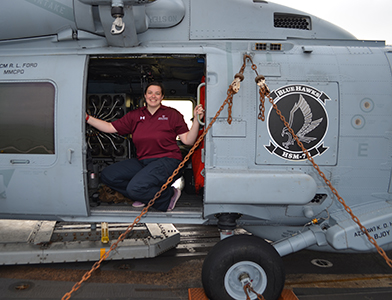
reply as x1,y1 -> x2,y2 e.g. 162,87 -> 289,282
85,54 -> 205,212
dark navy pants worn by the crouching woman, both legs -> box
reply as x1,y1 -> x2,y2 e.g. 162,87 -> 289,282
101,157 -> 180,211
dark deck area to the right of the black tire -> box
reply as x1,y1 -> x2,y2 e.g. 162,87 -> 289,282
283,250 -> 392,300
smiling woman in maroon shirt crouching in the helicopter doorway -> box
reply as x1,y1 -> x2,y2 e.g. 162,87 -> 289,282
86,82 -> 204,211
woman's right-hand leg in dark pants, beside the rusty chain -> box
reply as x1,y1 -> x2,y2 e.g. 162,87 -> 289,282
127,157 -> 180,211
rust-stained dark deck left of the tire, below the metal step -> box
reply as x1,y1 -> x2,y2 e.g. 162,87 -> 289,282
0,225 -> 220,300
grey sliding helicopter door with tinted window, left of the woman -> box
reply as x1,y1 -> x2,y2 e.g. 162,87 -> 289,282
0,55 -> 88,219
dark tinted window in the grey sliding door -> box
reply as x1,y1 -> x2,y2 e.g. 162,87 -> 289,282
0,82 -> 55,154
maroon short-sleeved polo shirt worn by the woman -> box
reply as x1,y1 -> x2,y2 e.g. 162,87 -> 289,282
112,105 -> 189,160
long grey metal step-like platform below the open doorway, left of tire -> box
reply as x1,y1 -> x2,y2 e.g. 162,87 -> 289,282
0,220 -> 180,265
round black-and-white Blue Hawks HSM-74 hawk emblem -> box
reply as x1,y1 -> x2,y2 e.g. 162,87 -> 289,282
264,85 -> 331,161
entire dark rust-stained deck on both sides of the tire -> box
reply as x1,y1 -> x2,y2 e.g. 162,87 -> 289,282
0,224 -> 392,300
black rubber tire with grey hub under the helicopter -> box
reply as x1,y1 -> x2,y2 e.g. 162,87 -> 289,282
202,235 -> 285,300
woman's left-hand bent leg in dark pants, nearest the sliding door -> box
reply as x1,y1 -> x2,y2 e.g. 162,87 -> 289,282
101,158 -> 144,200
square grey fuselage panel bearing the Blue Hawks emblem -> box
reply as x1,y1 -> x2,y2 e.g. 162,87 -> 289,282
256,81 -> 339,165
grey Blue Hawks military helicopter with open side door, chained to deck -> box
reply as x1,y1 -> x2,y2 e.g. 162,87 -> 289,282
0,0 -> 392,299
